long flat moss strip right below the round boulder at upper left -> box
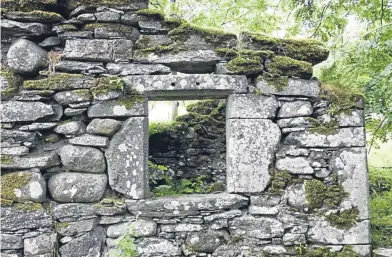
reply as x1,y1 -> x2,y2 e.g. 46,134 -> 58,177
23,73 -> 97,90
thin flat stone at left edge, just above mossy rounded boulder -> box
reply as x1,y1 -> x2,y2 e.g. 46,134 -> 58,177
1,152 -> 60,169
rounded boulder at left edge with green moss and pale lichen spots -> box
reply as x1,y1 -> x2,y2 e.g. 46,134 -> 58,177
1,171 -> 46,202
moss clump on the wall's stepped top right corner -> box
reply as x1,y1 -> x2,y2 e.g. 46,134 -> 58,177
320,83 -> 364,115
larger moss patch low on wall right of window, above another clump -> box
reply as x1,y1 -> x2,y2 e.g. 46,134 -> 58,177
305,179 -> 348,211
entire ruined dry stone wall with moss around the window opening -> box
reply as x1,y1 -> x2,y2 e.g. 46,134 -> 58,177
0,0 -> 371,257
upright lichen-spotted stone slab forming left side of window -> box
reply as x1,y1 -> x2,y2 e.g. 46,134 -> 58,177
105,117 -> 149,199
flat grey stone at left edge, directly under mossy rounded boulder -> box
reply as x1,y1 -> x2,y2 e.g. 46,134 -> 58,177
0,203 -> 52,231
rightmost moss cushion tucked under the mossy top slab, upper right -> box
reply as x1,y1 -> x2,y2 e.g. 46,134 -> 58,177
267,56 -> 313,79
